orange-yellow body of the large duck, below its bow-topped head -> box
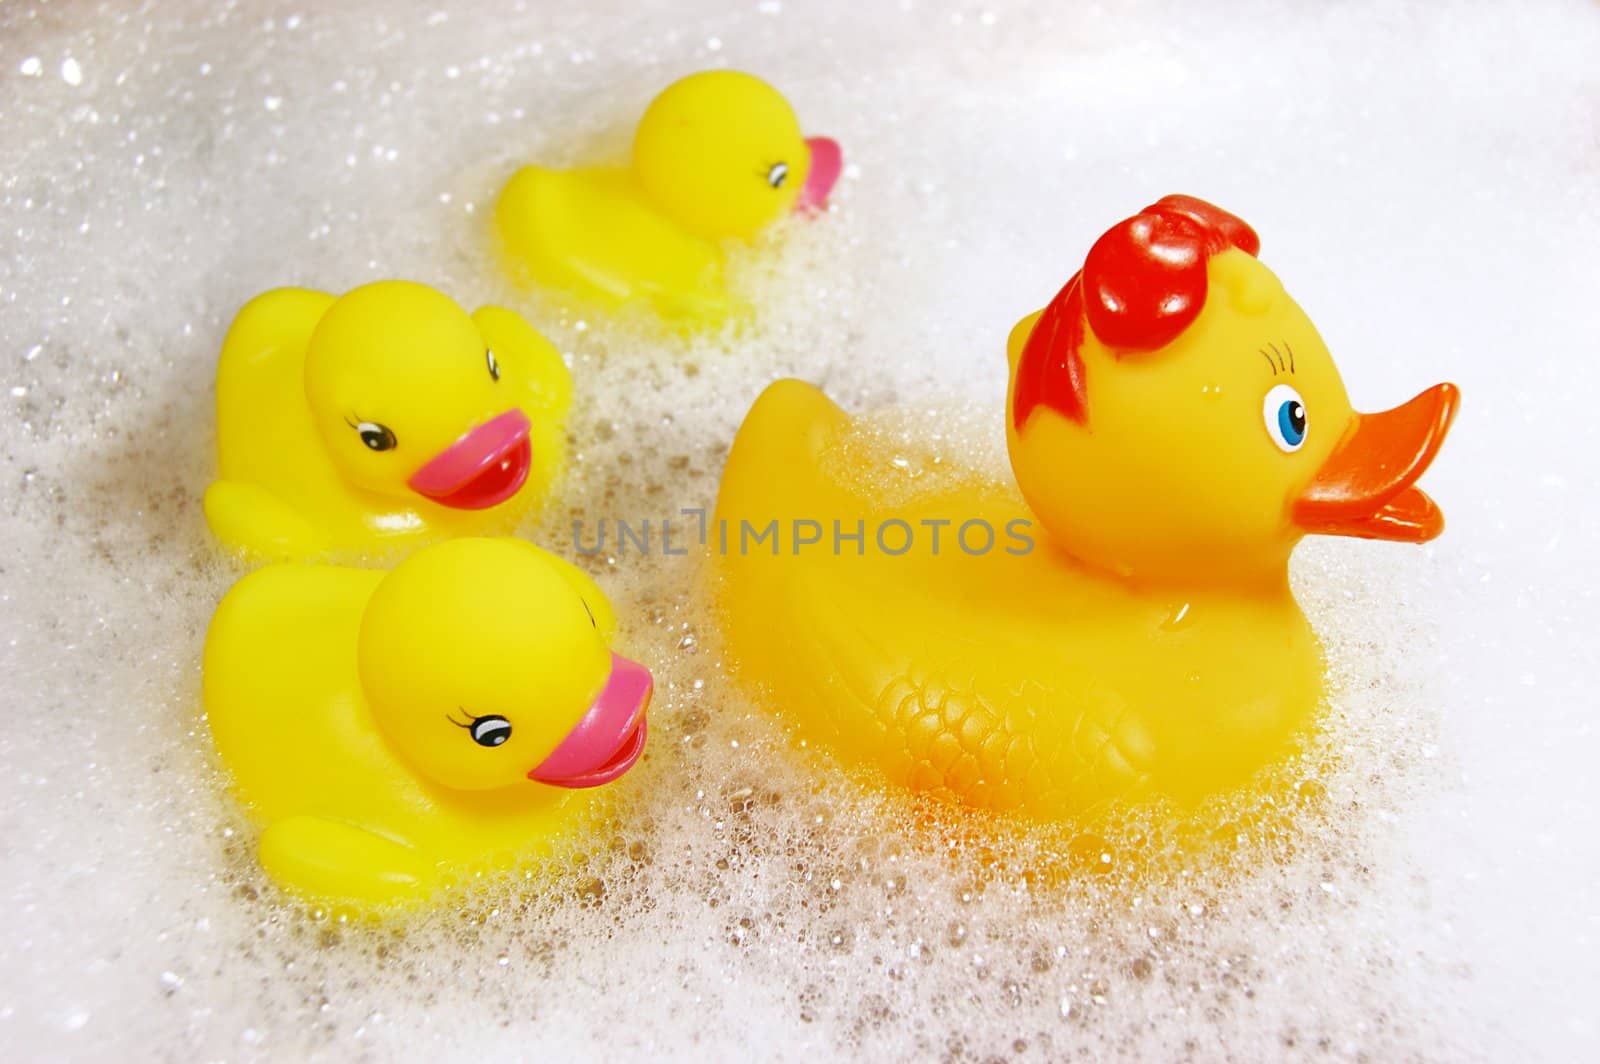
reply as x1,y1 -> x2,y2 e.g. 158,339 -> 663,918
717,381 -> 1322,816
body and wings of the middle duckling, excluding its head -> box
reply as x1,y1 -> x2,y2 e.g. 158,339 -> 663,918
205,282 -> 571,558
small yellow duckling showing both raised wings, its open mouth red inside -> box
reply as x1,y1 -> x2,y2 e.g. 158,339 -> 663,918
205,280 -> 573,558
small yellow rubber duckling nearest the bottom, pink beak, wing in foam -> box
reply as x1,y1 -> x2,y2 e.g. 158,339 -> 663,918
205,538 -> 651,910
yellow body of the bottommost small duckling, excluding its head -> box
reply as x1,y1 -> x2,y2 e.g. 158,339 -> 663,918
206,565 -> 566,901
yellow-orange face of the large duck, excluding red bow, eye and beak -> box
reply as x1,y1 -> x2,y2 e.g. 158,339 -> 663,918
1006,250 -> 1355,587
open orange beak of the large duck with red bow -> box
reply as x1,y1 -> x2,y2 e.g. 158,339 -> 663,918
1293,384 -> 1461,542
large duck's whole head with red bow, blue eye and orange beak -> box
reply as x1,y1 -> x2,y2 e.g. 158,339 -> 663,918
1006,197 -> 1459,582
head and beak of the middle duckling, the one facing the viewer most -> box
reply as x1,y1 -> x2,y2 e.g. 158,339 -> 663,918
306,282 -> 533,510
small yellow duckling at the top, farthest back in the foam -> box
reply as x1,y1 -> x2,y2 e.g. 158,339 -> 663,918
494,70 -> 843,325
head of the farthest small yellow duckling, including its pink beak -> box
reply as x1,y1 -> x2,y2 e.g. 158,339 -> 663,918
634,70 -> 843,240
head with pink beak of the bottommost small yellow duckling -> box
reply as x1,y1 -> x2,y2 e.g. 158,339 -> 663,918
357,539 -> 651,790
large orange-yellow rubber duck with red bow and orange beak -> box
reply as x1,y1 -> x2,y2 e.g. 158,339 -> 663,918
715,197 -> 1458,818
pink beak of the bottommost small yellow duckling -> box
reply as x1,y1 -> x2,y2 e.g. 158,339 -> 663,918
528,654 -> 654,787
